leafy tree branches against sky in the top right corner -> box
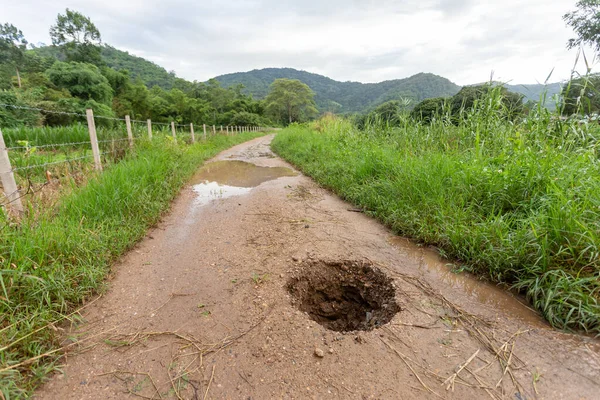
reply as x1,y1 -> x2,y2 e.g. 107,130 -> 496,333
563,0 -> 600,51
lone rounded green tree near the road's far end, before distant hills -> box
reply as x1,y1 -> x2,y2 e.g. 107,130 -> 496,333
265,79 -> 317,124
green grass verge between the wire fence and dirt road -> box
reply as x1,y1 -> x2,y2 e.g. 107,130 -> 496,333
0,133 -> 260,399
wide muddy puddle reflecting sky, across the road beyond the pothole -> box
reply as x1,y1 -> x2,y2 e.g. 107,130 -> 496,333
192,161 -> 297,206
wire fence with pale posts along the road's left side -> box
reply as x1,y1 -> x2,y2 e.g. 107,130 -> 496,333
0,103 -> 268,214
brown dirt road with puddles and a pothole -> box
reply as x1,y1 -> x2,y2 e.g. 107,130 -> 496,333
37,136 -> 600,400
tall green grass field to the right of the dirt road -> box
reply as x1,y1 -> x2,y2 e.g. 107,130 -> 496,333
273,93 -> 600,334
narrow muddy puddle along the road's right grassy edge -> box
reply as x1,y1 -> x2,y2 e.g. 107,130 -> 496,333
388,236 -> 547,327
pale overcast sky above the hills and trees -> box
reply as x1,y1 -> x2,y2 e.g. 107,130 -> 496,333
0,0 -> 591,85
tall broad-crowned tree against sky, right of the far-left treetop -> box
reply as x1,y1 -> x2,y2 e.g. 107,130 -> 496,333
50,8 -> 102,65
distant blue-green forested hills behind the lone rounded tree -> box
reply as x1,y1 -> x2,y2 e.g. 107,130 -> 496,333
215,68 -> 460,113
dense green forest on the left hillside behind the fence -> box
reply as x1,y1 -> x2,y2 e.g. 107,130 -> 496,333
0,9 -> 272,128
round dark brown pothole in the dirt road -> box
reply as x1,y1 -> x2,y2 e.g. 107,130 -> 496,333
287,261 -> 400,332
